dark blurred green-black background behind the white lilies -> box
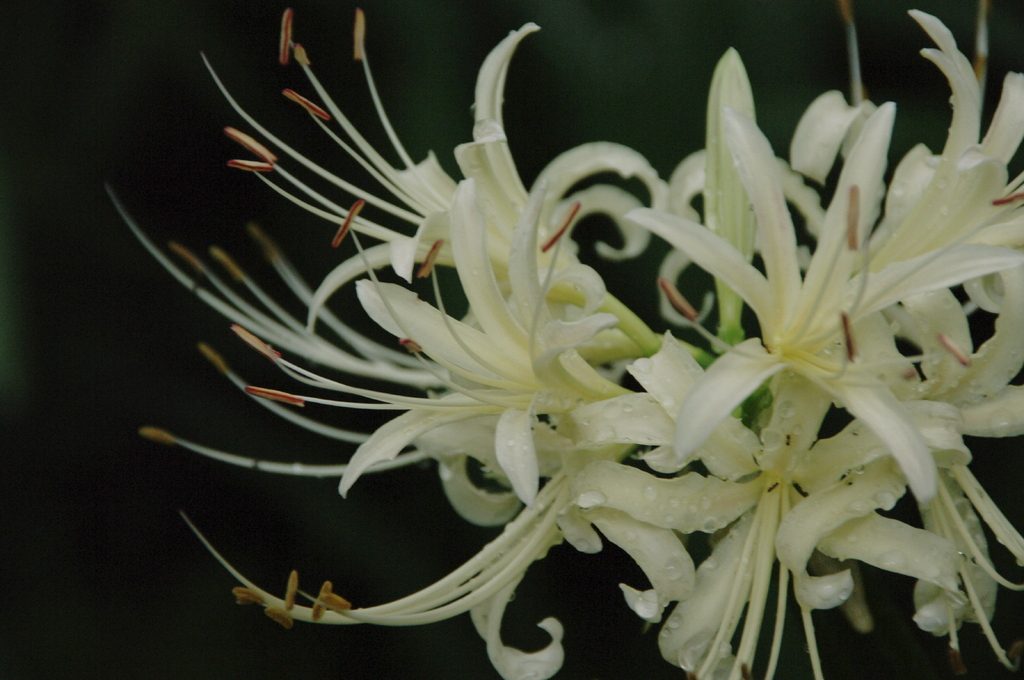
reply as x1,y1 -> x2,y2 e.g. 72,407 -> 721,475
0,0 -> 1024,680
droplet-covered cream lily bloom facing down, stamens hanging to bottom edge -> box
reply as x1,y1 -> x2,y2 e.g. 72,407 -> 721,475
562,335 -> 967,680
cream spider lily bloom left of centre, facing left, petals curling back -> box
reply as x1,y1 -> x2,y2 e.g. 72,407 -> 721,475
340,179 -> 640,505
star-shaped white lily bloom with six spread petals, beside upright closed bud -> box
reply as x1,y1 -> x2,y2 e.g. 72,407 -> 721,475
629,98 -> 1024,501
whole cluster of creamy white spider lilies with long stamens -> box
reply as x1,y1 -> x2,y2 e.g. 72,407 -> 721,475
122,10 -> 1024,680
